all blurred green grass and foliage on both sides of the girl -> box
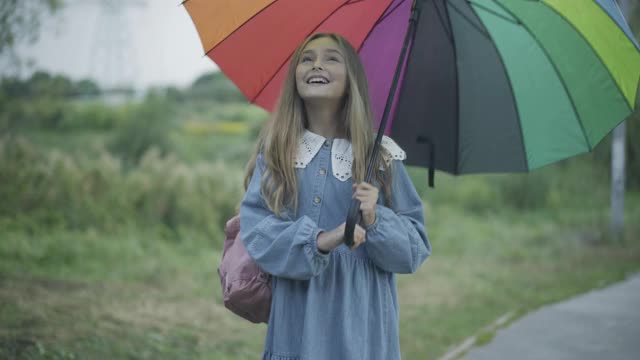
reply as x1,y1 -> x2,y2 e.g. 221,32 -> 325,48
0,67 -> 640,359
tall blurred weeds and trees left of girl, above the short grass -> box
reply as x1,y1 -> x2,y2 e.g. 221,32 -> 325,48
0,72 -> 266,246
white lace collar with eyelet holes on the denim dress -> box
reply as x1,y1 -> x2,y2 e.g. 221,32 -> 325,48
294,130 -> 407,181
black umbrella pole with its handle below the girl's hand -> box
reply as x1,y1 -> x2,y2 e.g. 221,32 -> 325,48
344,0 -> 422,247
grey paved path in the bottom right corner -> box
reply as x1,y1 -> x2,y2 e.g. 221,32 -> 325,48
463,275 -> 640,360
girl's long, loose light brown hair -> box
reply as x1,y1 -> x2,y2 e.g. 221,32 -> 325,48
244,33 -> 391,216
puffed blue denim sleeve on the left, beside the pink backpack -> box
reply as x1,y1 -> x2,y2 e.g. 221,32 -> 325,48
240,154 -> 330,280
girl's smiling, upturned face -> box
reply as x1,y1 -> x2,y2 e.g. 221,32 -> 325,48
296,37 -> 347,102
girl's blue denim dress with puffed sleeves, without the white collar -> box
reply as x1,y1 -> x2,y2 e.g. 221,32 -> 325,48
240,135 -> 431,360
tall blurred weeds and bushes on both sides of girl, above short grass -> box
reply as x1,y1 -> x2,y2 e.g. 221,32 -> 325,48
0,66 -> 640,244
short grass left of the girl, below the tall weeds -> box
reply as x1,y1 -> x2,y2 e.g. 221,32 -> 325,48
0,231 -> 265,359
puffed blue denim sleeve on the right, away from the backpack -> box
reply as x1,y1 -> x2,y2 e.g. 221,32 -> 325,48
364,160 -> 431,274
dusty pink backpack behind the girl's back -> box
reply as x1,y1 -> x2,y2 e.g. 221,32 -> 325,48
218,215 -> 271,323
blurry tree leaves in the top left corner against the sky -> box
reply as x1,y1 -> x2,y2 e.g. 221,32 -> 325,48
0,0 -> 64,67
